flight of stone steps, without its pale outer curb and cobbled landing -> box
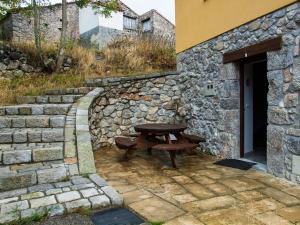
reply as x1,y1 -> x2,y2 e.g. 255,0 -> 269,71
0,87 -> 92,191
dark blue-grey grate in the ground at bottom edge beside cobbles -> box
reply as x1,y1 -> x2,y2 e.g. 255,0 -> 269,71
91,208 -> 145,225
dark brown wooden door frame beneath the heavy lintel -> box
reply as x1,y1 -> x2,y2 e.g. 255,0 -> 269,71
239,52 -> 267,158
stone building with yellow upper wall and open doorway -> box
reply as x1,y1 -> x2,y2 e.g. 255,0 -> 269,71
176,0 -> 300,183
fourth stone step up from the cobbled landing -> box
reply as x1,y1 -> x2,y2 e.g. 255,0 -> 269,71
0,115 -> 66,129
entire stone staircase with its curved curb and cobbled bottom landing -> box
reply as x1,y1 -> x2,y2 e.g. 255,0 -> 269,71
0,87 -> 123,224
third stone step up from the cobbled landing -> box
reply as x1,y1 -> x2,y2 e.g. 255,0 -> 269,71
0,128 -> 64,144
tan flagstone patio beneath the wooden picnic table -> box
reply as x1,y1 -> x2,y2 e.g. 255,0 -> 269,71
95,147 -> 300,225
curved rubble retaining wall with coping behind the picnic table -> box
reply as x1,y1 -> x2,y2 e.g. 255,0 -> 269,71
87,73 -> 186,150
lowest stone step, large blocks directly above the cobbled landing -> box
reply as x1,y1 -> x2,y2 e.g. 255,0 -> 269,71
0,163 -> 68,192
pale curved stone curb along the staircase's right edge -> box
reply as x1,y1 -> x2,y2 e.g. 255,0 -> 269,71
76,88 -> 104,174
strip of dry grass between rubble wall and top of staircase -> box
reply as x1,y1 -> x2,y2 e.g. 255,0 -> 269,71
0,73 -> 85,105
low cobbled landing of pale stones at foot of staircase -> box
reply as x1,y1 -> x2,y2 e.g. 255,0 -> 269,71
0,174 -> 123,224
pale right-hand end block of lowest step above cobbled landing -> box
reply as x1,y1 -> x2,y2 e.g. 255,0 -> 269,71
37,167 -> 67,184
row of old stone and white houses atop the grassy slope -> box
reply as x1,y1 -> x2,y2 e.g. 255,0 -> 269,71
0,1 -> 175,48
